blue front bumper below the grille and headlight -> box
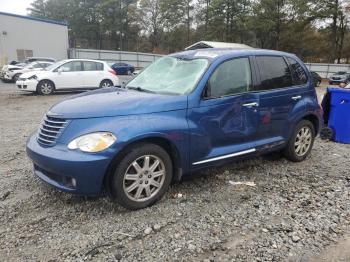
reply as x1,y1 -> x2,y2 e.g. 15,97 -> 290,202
27,133 -> 111,195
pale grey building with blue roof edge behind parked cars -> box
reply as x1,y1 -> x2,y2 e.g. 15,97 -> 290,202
0,12 -> 68,65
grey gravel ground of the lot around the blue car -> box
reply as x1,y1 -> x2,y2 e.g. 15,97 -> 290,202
0,81 -> 350,261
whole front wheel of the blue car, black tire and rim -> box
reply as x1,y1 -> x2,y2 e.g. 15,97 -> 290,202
110,143 -> 173,210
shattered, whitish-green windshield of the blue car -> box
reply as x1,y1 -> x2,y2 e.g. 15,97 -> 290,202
126,56 -> 208,95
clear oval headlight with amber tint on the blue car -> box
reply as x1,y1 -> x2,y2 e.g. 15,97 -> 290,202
68,132 -> 117,153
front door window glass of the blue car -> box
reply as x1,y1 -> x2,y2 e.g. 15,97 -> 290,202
206,57 -> 252,98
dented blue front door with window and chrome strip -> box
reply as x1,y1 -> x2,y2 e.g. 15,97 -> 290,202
188,57 -> 259,168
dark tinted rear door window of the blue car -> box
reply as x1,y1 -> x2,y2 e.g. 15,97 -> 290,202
256,56 -> 293,90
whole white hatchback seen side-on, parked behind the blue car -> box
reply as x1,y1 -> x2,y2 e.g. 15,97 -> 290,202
16,59 -> 119,95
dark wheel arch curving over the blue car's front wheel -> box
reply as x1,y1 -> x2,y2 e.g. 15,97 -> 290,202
103,136 -> 182,194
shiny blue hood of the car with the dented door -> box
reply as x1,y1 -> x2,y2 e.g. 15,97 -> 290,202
48,88 -> 187,119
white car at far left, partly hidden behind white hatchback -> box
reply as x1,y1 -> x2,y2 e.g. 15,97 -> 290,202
2,61 -> 53,82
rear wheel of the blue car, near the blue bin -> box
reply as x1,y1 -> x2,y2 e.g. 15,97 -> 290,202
283,120 -> 316,162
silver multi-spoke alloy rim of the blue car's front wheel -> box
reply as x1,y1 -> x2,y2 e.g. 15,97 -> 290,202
123,155 -> 165,202
